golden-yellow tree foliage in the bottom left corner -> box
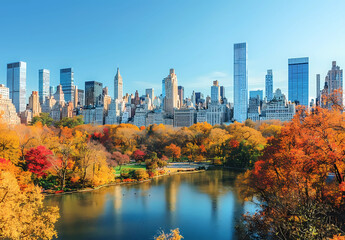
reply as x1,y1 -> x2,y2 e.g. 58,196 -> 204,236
0,159 -> 59,240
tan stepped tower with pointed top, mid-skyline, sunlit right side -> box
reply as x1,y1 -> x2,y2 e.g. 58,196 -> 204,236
164,68 -> 178,115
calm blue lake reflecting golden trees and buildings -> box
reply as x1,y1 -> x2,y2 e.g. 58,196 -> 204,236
45,170 -> 252,240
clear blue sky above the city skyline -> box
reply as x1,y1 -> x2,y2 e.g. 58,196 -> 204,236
0,0 -> 345,102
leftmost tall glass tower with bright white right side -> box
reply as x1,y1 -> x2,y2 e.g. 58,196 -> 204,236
7,62 -> 26,112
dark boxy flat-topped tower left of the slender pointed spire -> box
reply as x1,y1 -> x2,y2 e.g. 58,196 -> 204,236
85,81 -> 103,106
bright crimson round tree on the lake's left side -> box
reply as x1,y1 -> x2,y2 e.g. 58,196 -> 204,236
25,146 -> 53,177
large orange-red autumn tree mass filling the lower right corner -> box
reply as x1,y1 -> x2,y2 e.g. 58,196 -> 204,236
237,108 -> 345,239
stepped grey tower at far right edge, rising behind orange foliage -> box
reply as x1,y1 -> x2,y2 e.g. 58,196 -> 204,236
325,61 -> 343,107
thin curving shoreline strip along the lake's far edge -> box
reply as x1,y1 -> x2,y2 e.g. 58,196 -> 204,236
42,169 -> 206,197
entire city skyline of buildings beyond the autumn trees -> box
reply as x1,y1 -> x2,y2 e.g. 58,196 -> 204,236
0,43 -> 343,127
